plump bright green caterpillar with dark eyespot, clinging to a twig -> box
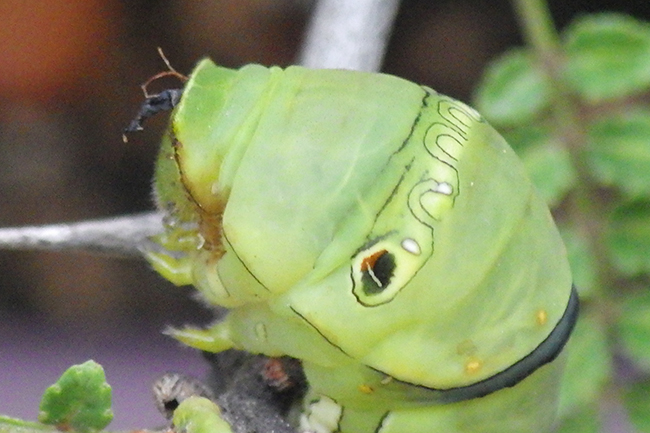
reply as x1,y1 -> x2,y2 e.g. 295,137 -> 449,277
139,60 -> 578,433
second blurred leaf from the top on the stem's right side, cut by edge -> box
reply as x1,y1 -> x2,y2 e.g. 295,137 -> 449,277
587,109 -> 650,198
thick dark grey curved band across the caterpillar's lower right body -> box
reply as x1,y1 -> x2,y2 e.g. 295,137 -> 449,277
370,285 -> 580,403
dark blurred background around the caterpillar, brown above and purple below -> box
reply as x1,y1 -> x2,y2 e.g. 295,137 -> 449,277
0,0 -> 650,429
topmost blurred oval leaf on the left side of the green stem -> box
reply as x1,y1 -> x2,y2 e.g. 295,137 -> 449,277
475,49 -> 550,127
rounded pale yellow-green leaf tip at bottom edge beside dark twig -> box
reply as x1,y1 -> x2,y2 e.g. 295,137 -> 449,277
173,396 -> 232,433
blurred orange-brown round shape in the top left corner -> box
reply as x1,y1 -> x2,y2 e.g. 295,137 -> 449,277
0,0 -> 117,101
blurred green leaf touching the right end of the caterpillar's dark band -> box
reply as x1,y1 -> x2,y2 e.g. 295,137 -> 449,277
560,311 -> 613,417
